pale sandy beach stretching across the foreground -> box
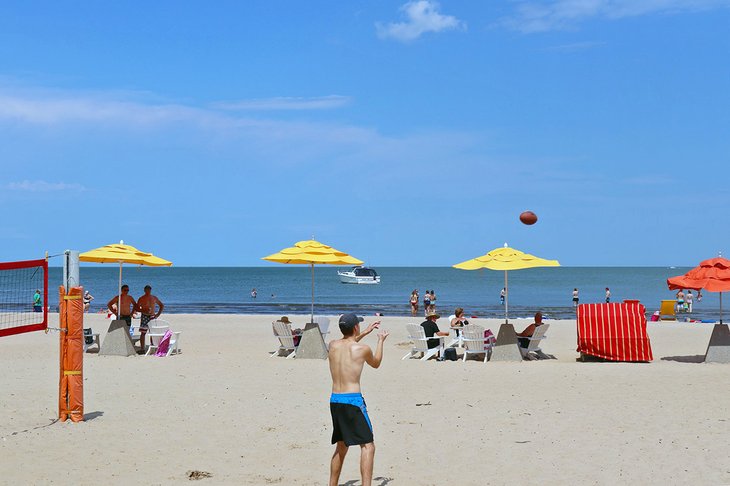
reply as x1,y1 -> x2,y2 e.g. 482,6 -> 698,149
0,314 -> 730,485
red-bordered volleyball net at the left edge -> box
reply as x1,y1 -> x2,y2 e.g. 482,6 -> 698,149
0,259 -> 48,337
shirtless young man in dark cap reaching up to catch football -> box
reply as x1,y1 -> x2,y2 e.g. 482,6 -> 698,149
329,314 -> 388,486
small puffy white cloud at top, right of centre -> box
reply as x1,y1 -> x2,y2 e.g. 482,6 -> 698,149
375,0 -> 466,42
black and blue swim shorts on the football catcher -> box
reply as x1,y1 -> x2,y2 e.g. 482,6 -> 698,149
330,393 -> 373,446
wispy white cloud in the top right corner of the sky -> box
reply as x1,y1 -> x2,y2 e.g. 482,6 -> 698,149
503,0 -> 730,33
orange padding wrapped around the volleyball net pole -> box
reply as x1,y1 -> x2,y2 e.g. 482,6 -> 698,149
58,287 -> 84,422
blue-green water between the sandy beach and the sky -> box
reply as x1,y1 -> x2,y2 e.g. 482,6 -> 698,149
42,265 -> 719,319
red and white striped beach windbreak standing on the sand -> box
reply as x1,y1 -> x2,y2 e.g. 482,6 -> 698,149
578,302 -> 654,361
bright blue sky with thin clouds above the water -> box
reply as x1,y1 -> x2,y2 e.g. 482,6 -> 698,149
0,0 -> 730,266
